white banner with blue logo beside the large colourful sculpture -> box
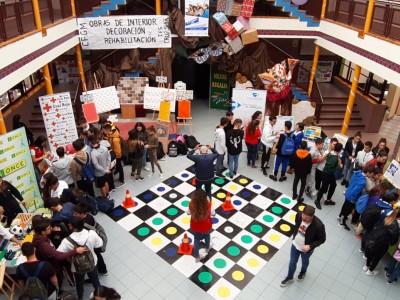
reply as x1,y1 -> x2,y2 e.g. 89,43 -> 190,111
232,89 -> 267,124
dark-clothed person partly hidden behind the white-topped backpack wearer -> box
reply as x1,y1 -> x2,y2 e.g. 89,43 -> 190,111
74,203 -> 109,276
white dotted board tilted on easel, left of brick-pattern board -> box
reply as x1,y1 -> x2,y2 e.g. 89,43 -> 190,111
82,86 -> 121,114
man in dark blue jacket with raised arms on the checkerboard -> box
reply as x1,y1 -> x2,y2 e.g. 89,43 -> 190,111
187,145 -> 219,199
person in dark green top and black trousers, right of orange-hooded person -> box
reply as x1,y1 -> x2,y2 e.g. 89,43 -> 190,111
314,143 -> 343,209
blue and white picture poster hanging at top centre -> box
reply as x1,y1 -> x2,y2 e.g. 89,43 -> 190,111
185,0 -> 210,36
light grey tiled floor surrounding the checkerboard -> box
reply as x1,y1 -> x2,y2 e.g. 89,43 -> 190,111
79,100 -> 400,300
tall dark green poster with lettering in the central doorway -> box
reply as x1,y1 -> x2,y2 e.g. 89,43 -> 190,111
210,64 -> 231,110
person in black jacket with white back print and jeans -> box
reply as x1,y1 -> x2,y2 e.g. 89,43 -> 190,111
226,119 -> 244,178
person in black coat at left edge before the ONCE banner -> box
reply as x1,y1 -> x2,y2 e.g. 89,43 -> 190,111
0,177 -> 26,226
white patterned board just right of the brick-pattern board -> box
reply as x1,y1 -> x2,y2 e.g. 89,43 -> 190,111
143,86 -> 176,113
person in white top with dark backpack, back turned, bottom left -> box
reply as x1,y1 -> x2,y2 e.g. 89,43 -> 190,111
57,217 -> 103,299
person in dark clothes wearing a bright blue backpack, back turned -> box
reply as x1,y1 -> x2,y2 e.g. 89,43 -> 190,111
269,121 -> 294,182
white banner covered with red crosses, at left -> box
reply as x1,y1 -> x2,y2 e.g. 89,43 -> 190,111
39,92 -> 78,153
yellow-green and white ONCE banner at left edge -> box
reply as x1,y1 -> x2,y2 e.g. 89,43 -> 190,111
0,127 -> 43,213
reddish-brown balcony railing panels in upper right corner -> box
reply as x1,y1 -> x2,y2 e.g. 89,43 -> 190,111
326,0 -> 400,40
